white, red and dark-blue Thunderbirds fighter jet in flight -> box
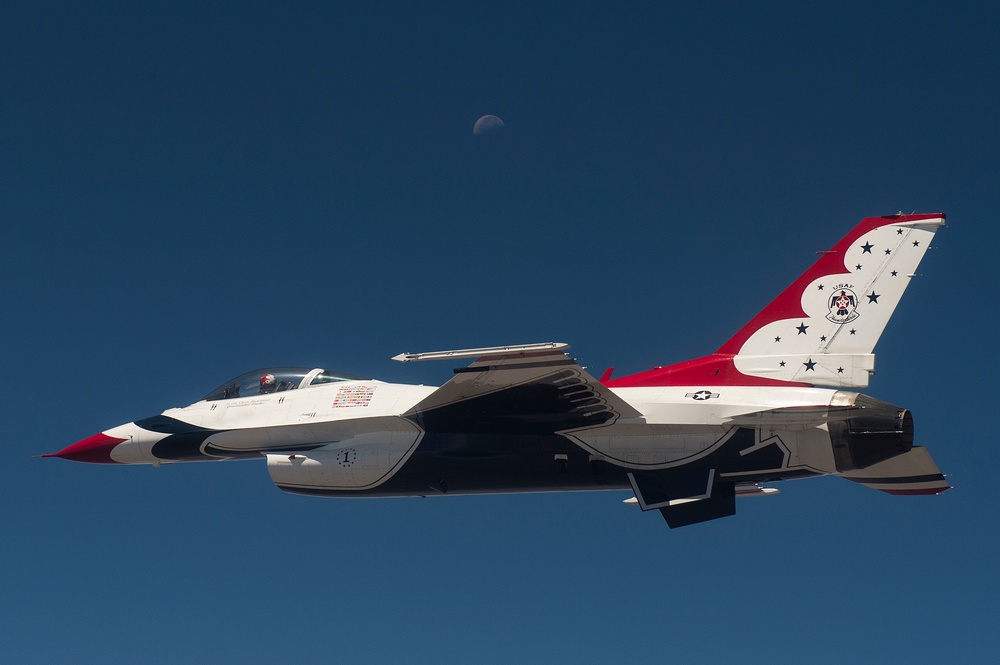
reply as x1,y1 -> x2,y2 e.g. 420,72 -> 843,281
46,213 -> 949,527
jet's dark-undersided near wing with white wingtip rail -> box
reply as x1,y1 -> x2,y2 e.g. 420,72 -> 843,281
394,343 -> 641,435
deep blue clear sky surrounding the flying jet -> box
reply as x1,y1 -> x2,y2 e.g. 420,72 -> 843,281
0,1 -> 1000,663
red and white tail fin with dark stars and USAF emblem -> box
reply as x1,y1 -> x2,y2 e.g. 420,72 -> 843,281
608,213 -> 945,388
